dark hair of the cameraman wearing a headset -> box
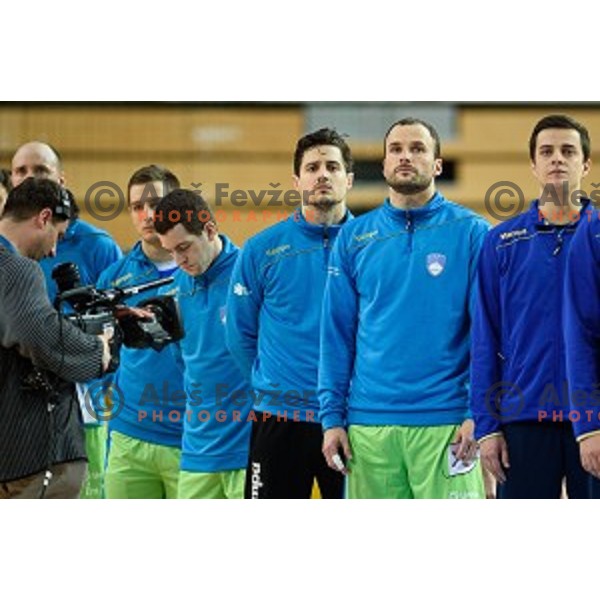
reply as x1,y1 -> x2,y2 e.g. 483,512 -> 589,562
3,177 -> 73,222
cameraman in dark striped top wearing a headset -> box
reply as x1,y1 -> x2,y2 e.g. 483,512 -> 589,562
0,179 -> 111,498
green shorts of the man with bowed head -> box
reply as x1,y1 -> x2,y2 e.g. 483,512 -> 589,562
178,469 -> 246,500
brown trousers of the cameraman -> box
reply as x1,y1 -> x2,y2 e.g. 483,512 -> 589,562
0,460 -> 87,500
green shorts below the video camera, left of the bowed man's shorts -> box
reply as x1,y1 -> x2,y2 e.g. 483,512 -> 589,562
104,431 -> 181,500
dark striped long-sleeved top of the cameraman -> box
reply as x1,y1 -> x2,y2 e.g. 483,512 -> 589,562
0,238 -> 102,482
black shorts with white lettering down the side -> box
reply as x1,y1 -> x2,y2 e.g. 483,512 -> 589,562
246,413 -> 344,500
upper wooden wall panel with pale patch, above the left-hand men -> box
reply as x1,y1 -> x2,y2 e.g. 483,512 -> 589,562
21,105 -> 303,155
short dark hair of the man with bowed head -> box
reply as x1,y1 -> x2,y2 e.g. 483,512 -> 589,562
154,189 -> 216,235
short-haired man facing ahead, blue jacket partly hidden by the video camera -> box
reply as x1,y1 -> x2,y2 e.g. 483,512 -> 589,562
98,165 -> 185,499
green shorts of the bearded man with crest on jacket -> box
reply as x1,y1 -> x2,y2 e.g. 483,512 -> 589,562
347,426 -> 485,500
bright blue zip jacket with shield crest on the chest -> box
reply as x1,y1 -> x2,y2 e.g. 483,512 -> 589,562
319,193 -> 489,430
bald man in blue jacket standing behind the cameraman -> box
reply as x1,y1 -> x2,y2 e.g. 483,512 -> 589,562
11,141 -> 123,499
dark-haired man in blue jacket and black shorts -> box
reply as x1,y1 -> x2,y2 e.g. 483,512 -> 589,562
227,129 -> 353,499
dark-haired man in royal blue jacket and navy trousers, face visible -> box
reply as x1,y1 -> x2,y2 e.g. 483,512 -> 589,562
472,115 -> 590,499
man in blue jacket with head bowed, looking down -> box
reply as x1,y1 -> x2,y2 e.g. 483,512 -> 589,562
156,190 -> 255,500
